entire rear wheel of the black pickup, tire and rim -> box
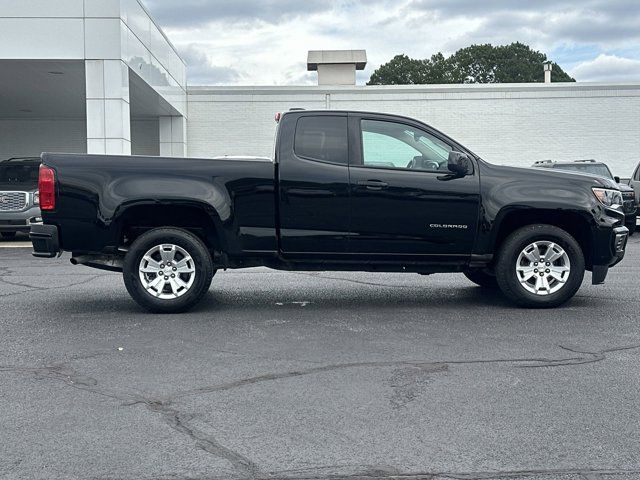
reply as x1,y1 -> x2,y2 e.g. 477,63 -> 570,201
123,228 -> 215,313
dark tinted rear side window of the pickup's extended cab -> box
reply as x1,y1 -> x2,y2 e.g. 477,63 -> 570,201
293,115 -> 349,165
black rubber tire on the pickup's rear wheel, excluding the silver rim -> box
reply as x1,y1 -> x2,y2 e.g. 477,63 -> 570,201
123,228 -> 215,313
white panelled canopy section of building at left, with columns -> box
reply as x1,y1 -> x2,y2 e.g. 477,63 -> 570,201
0,0 -> 187,158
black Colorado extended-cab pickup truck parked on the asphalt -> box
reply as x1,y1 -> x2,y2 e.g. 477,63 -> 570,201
31,111 -> 629,312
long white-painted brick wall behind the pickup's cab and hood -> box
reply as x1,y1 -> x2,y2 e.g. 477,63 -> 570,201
188,83 -> 640,177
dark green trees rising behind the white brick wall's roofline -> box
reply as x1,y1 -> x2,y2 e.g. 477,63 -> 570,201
368,42 -> 575,85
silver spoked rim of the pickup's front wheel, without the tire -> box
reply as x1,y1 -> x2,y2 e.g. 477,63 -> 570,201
516,241 -> 571,295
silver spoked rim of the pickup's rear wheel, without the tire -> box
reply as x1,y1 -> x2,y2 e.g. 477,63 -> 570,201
138,243 -> 196,300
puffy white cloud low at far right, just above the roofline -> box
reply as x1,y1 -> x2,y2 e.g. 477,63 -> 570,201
571,54 -> 640,82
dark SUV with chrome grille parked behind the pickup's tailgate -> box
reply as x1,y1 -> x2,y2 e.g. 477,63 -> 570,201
0,157 -> 42,239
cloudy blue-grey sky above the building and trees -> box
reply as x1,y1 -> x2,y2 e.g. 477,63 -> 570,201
143,0 -> 640,85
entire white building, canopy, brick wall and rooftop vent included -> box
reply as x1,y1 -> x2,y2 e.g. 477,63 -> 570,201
0,0 -> 640,177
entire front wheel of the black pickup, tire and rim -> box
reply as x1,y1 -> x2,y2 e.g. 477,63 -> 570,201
495,225 -> 585,308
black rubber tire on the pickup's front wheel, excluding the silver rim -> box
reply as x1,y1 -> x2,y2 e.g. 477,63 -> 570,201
495,224 -> 585,308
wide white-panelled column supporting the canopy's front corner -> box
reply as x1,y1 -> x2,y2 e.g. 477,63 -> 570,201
85,60 -> 131,155
